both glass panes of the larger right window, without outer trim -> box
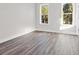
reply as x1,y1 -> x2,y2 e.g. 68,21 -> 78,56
63,3 -> 73,25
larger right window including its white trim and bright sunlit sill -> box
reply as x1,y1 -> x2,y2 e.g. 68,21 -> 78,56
60,3 -> 75,30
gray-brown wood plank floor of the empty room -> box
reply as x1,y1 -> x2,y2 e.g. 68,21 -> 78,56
0,31 -> 79,55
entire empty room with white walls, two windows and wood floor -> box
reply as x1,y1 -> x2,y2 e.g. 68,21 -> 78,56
0,3 -> 79,55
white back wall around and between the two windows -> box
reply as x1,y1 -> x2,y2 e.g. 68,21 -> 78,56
36,3 -> 76,34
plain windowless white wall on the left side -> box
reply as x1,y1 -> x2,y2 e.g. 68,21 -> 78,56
0,3 -> 35,43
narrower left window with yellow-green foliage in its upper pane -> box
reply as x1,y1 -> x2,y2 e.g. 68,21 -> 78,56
40,4 -> 48,24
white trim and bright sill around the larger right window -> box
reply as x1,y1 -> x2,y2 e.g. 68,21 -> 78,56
60,3 -> 76,30
